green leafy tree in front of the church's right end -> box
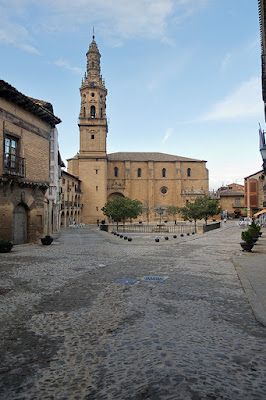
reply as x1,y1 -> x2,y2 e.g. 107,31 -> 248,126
180,196 -> 221,230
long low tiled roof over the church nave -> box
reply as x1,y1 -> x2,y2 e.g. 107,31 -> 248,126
107,152 -> 206,162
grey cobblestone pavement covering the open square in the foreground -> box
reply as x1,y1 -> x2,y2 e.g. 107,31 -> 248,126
0,225 -> 266,400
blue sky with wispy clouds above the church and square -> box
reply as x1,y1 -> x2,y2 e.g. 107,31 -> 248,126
0,0 -> 266,190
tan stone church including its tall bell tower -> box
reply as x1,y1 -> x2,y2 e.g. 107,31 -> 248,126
67,36 -> 209,224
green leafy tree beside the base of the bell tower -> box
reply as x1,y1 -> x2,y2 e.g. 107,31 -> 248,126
102,196 -> 142,228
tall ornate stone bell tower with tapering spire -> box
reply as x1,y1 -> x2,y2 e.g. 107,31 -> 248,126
73,35 -> 108,224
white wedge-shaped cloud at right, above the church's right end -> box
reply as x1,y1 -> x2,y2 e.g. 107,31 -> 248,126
199,77 -> 263,121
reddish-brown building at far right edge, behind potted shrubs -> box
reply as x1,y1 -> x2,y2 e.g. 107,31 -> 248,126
244,170 -> 266,217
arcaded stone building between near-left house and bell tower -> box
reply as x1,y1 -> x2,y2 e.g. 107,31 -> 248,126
61,171 -> 82,228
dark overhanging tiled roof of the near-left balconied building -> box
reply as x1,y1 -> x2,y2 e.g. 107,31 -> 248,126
0,80 -> 61,126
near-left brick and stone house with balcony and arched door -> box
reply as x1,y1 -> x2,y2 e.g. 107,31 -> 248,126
0,80 -> 61,244
